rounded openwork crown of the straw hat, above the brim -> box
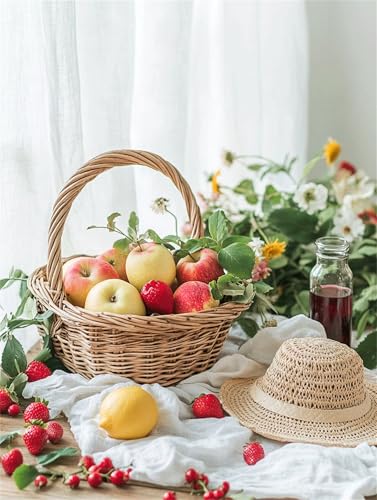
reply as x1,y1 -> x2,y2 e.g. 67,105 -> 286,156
258,338 -> 366,410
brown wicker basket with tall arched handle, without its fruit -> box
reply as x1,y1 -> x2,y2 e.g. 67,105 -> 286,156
28,150 -> 249,386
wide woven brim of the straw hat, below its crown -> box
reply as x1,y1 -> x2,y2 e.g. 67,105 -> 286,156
220,378 -> 377,448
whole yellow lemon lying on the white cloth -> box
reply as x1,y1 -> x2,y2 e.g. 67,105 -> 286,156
99,385 -> 158,439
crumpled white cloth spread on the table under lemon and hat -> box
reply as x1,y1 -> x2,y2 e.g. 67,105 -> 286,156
24,315 -> 377,500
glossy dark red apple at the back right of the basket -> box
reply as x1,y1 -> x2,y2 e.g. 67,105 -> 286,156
177,248 -> 224,283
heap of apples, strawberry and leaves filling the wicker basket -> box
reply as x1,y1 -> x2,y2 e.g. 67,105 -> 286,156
63,202 -> 255,316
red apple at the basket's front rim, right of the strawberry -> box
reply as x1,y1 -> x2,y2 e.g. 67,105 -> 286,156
174,281 -> 220,314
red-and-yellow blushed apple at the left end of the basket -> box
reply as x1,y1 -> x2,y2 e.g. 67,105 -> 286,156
63,257 -> 119,307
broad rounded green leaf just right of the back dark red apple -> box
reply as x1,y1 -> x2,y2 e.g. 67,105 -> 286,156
219,243 -> 255,279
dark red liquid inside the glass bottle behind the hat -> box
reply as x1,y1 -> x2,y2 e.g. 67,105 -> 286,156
310,285 -> 352,345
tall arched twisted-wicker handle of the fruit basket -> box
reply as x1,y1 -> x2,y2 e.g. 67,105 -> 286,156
47,150 -> 203,292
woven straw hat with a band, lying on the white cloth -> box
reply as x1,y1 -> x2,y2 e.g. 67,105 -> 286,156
220,338 -> 377,447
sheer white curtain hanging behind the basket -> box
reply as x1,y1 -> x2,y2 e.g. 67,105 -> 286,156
0,0 -> 308,303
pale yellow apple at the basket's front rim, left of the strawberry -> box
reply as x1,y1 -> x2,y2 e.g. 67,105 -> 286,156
85,279 -> 146,316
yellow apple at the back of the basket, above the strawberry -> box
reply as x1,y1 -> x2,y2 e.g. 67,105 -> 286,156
126,243 -> 175,290
